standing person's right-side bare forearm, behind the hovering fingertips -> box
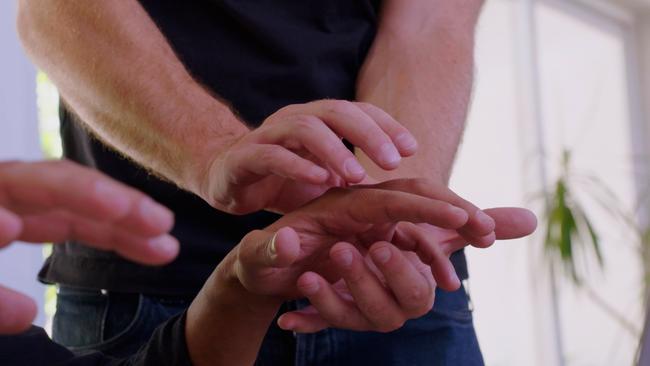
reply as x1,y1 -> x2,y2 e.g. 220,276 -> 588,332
357,0 -> 481,183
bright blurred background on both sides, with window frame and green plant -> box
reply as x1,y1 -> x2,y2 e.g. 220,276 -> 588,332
0,0 -> 650,366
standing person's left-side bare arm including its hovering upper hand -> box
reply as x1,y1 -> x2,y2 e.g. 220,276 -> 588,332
18,0 -> 417,214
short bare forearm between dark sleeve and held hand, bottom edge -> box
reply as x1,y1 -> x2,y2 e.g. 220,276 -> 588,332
185,258 -> 281,366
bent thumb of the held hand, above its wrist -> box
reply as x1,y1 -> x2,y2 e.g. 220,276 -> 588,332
239,227 -> 300,269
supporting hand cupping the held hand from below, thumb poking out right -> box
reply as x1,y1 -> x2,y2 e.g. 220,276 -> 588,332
278,207 -> 537,333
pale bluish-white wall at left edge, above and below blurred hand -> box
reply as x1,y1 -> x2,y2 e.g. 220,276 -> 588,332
0,1 -> 45,325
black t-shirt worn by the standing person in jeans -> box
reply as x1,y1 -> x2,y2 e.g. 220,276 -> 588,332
40,0 -> 466,296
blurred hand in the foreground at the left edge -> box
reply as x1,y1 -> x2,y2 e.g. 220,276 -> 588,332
0,161 -> 179,334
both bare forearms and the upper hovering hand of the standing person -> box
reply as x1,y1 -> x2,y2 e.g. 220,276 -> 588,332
18,0 -> 482,214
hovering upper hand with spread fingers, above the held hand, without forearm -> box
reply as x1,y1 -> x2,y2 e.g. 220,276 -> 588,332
199,100 -> 417,214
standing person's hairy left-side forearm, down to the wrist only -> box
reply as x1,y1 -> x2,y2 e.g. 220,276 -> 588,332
18,0 -> 247,192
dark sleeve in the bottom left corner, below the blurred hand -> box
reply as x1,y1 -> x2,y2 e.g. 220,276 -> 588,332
0,313 -> 192,366
